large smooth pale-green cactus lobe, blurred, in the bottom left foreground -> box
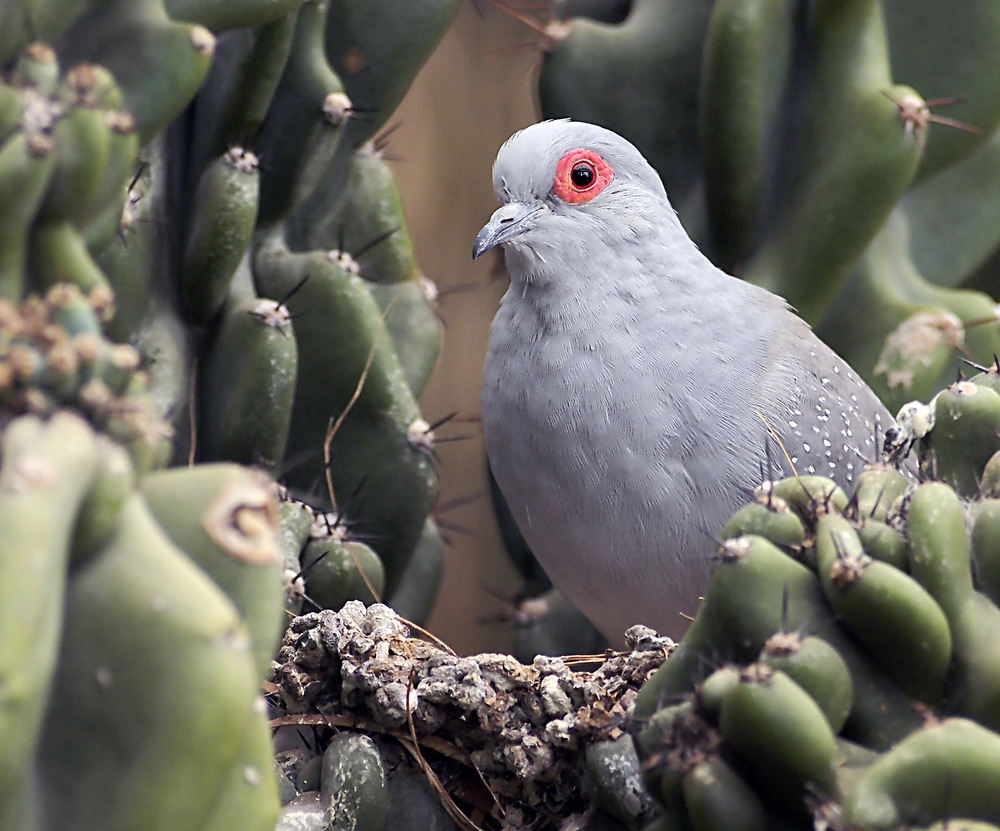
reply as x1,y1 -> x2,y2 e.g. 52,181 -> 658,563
37,492 -> 277,829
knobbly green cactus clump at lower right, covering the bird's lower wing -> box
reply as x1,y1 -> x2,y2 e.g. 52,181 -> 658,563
635,369 -> 1000,829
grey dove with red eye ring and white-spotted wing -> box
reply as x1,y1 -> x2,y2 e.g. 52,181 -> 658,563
472,119 -> 908,644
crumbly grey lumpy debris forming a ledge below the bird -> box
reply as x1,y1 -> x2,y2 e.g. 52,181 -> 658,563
274,601 -> 673,824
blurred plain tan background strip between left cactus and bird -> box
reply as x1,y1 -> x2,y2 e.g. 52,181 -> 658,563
389,0 -> 538,654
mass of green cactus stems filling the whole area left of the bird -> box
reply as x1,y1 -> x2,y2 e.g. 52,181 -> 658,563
0,0 -> 458,831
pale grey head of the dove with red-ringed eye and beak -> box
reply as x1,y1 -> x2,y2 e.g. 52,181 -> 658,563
472,119 -> 677,264
